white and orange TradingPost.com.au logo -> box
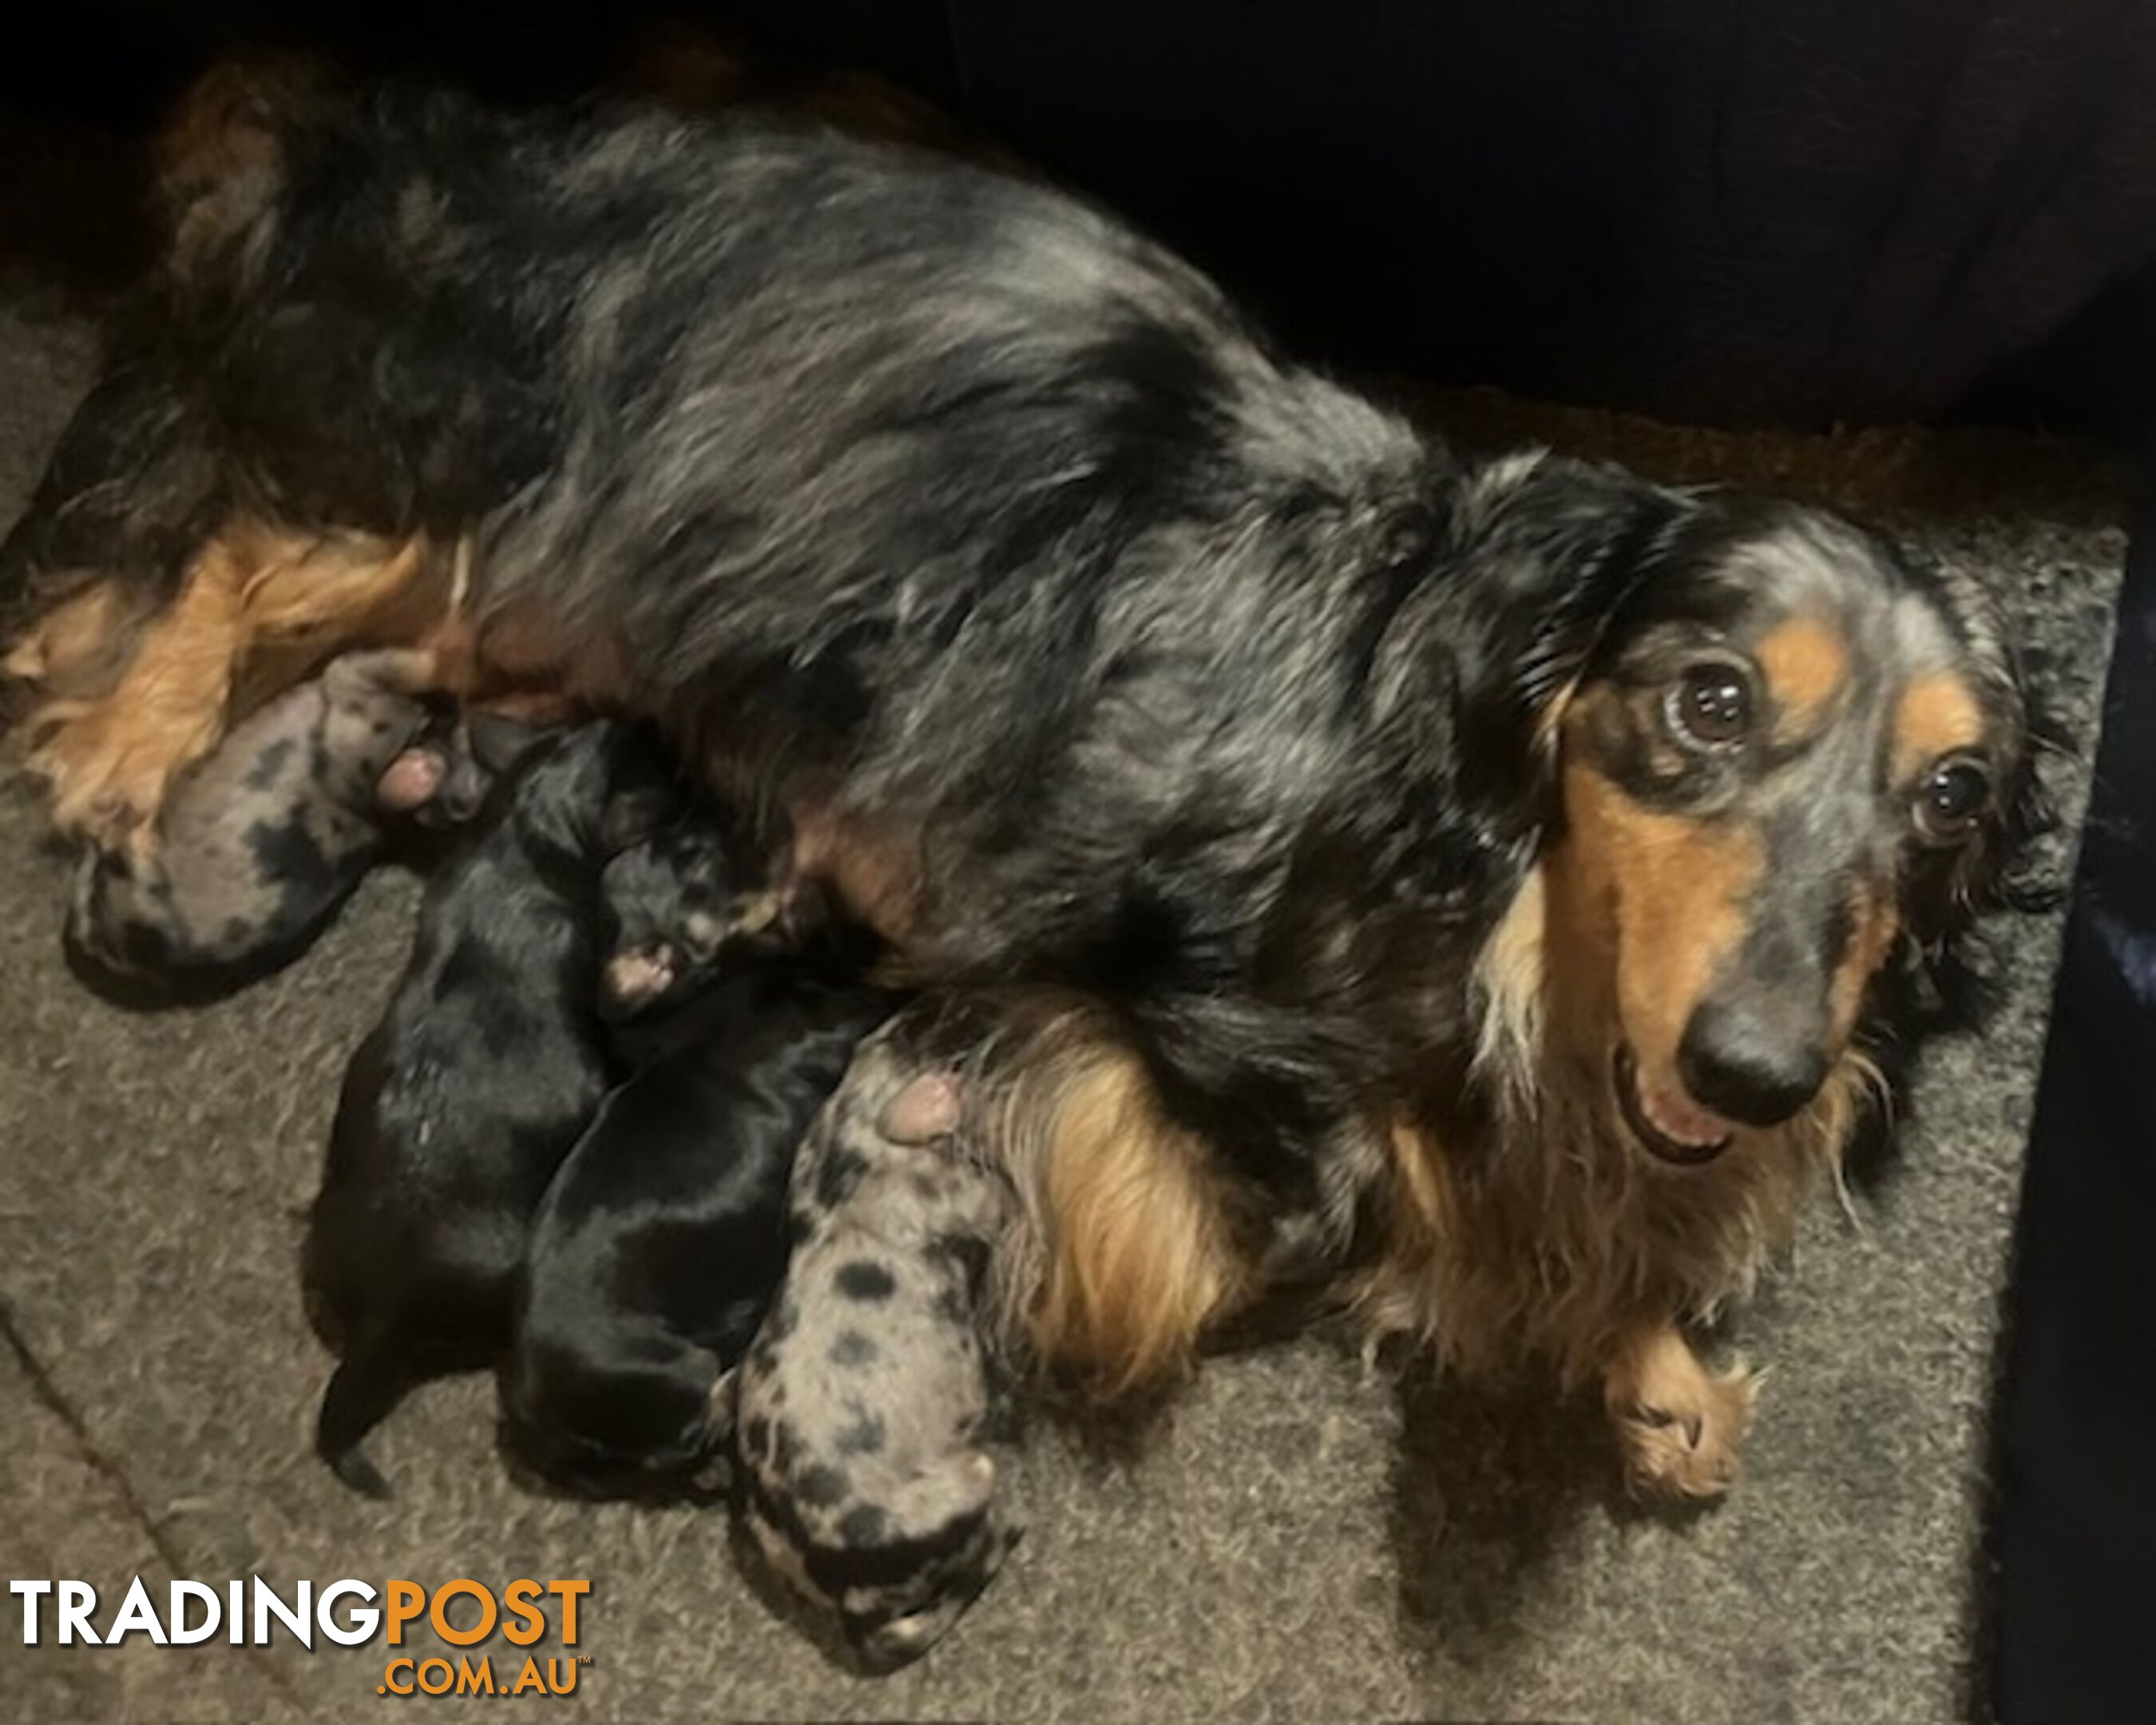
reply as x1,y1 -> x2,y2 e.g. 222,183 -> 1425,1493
6,1576 -> 591,1695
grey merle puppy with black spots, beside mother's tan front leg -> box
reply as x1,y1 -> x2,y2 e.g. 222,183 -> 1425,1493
737,1025 -> 1016,1669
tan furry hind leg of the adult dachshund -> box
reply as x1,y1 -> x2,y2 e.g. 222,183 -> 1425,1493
28,530 -> 425,852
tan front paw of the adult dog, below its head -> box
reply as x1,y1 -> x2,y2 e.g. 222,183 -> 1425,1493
1602,1324 -> 1759,1499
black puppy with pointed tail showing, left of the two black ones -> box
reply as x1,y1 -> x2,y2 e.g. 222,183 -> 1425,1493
306,723 -> 672,1497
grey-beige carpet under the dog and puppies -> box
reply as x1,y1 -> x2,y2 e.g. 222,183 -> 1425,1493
0,302 -> 2124,1725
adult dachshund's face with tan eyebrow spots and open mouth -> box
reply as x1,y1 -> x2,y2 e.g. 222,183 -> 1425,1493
1517,485 -> 2033,1164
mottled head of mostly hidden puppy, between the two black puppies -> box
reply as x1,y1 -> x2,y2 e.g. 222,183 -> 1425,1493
600,822 -> 794,1017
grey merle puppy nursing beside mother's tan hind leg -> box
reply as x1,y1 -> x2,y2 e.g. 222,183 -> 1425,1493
65,649 -> 485,981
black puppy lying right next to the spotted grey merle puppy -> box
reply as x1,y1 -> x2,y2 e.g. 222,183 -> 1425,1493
502,914 -> 897,1497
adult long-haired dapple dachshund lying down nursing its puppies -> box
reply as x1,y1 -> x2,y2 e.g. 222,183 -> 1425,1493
13,76 -> 2031,1494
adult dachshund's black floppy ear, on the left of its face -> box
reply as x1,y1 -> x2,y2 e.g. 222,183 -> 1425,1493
1453,453 -> 1701,822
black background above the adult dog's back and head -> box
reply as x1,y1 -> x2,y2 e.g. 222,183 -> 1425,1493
12,0 -> 2156,435
